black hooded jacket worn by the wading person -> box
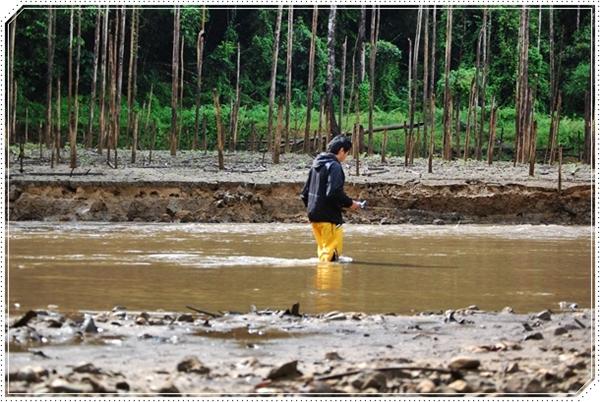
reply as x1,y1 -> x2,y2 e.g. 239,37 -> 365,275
300,152 -> 352,225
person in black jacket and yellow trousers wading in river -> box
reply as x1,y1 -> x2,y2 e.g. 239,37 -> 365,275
300,135 -> 361,262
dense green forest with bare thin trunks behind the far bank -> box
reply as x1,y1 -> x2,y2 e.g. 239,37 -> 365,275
6,5 -> 593,167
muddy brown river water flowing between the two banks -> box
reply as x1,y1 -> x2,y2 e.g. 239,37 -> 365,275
7,222 -> 593,314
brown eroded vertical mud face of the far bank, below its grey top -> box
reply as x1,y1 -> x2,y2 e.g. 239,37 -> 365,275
8,179 -> 592,224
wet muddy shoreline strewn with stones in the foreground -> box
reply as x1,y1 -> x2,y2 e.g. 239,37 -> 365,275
7,303 -> 594,396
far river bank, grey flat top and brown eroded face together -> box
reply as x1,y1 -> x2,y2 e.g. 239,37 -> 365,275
8,151 -> 593,225
